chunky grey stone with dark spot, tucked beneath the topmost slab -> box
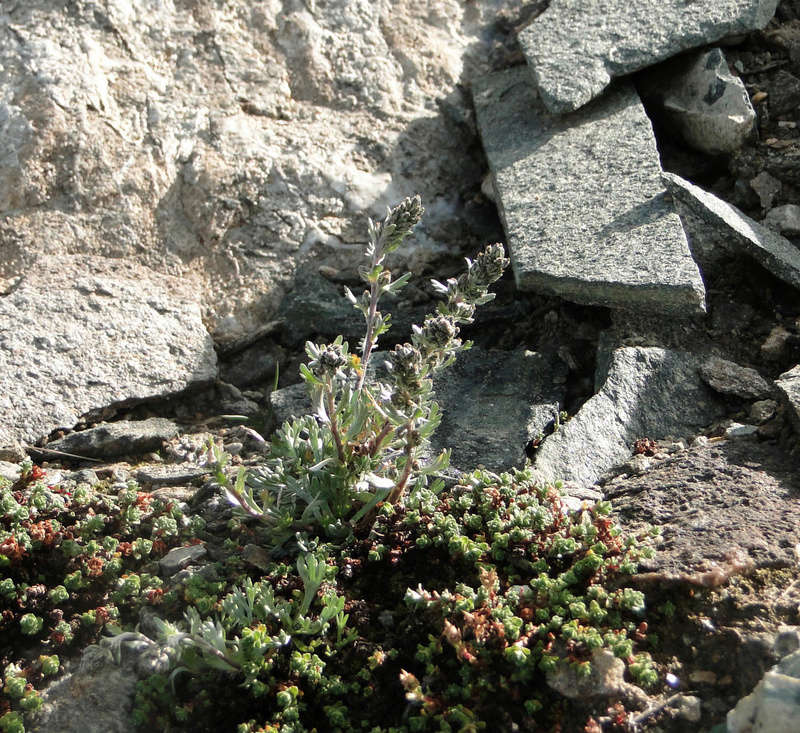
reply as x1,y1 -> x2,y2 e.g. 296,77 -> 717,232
637,48 -> 756,155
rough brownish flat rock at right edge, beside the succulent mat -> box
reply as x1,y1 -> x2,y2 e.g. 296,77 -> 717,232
606,440 -> 800,574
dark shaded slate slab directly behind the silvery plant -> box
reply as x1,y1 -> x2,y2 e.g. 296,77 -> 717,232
270,347 -> 566,472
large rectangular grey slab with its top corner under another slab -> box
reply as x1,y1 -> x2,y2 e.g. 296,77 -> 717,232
473,67 -> 705,314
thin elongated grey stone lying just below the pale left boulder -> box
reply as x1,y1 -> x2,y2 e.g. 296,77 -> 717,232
45,417 -> 179,459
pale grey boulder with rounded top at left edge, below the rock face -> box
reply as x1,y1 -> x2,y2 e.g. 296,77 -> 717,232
0,256 -> 216,445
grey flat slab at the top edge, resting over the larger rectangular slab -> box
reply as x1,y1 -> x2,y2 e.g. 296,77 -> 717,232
519,0 -> 778,113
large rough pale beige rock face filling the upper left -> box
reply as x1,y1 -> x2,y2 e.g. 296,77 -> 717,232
0,0 -> 500,340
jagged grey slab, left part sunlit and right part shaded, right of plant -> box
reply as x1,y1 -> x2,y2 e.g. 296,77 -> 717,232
534,347 -> 724,484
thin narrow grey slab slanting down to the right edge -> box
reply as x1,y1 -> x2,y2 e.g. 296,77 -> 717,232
663,173 -> 800,288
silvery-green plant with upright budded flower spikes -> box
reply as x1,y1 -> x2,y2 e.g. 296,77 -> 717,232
217,197 -> 508,544
